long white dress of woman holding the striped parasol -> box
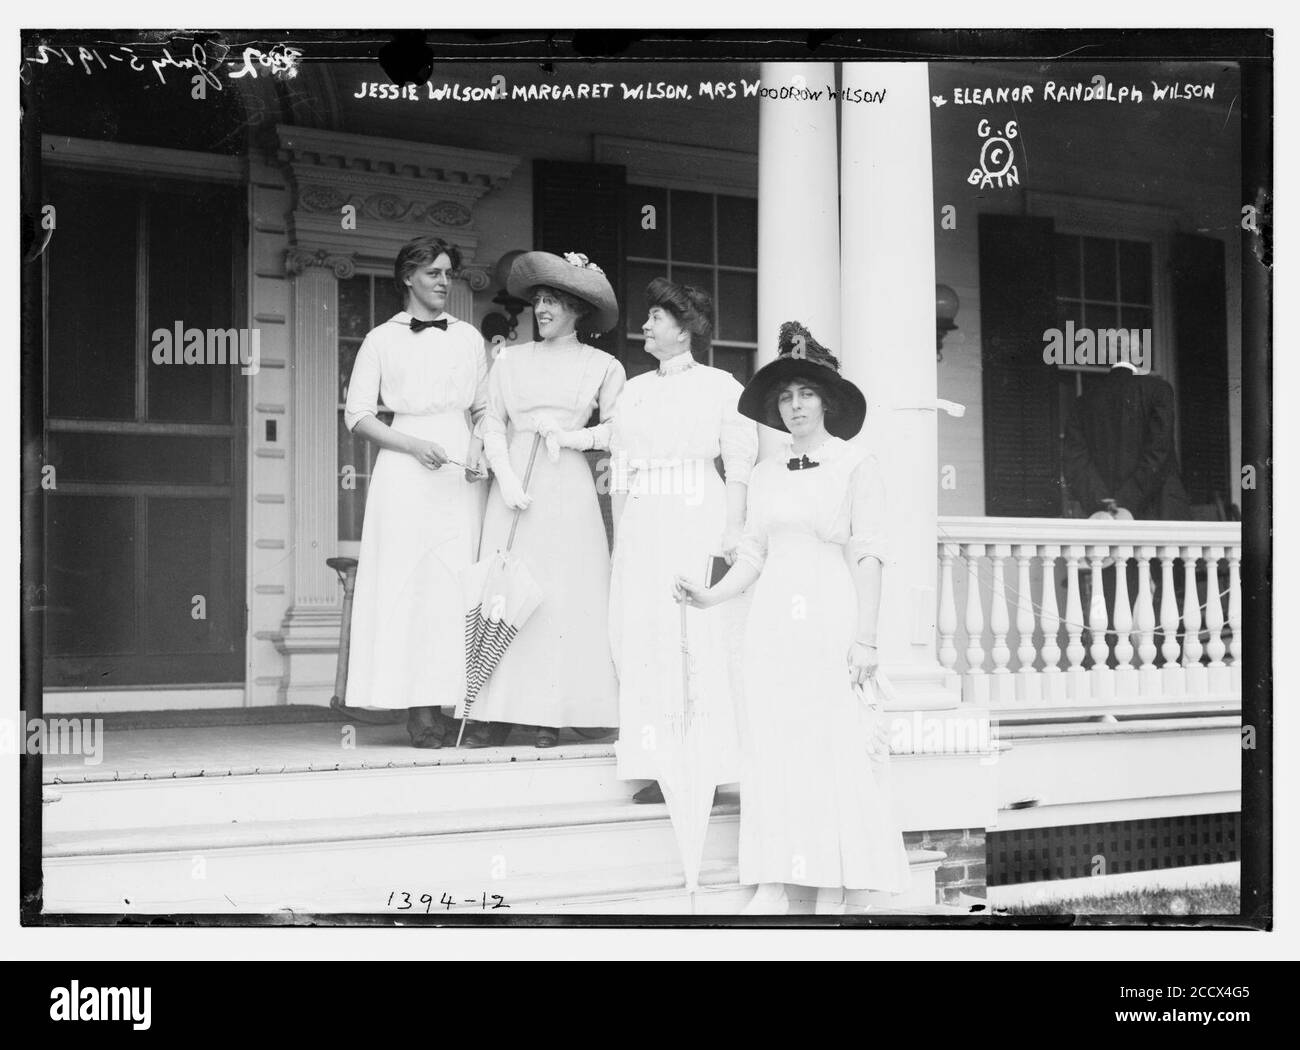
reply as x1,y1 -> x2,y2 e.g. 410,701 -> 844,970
469,338 -> 627,728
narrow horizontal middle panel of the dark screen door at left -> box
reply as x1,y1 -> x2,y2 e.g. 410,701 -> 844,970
46,431 -> 230,485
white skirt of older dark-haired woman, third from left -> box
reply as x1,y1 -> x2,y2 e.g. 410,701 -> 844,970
610,460 -> 740,784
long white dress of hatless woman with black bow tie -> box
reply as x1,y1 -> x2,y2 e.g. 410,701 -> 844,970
343,312 -> 488,708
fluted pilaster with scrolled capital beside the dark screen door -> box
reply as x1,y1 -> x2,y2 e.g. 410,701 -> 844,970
280,250 -> 354,703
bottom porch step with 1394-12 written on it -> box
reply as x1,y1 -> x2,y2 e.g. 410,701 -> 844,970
44,798 -> 943,916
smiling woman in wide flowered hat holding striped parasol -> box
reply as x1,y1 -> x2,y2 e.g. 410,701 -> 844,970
467,252 -> 627,747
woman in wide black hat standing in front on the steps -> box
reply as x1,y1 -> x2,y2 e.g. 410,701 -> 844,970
677,322 -> 909,914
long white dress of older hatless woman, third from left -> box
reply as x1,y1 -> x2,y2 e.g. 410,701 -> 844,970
610,353 -> 758,784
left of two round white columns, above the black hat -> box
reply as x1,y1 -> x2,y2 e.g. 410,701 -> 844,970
754,62 -> 840,456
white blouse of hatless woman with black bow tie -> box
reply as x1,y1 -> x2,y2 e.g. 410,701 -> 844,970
343,311 -> 488,430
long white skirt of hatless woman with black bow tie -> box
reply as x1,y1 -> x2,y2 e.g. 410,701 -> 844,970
346,412 -> 481,708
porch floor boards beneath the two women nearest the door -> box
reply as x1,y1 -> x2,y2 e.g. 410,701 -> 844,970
42,715 -> 615,784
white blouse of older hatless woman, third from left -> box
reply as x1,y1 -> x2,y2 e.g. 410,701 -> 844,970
608,355 -> 758,489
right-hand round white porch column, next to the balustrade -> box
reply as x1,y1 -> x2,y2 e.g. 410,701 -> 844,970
837,62 -> 961,708
